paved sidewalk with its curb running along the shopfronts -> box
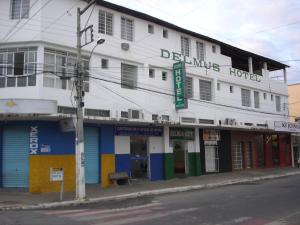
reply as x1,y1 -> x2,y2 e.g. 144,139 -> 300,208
0,168 -> 300,210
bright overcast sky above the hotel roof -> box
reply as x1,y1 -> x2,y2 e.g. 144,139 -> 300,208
107,0 -> 300,83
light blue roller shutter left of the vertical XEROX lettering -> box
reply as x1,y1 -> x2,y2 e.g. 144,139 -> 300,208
2,126 -> 29,187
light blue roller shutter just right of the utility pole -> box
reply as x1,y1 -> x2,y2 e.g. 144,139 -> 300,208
84,127 -> 100,184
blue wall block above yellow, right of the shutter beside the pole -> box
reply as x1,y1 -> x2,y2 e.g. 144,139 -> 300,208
100,125 -> 115,154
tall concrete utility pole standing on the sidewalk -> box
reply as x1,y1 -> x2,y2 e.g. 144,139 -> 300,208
75,0 -> 96,200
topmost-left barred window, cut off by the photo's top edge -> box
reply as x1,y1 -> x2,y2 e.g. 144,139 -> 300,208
10,0 -> 30,19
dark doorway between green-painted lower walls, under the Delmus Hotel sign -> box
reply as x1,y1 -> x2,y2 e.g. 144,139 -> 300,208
172,140 -> 187,177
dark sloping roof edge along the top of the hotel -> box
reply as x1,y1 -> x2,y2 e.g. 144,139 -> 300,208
96,0 -> 289,69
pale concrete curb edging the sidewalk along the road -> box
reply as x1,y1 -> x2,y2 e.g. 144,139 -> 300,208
0,171 -> 300,211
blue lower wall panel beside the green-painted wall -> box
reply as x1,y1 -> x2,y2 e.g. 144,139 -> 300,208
150,153 -> 164,181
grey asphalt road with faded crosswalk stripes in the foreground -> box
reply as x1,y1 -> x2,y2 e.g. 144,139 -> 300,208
0,176 -> 300,225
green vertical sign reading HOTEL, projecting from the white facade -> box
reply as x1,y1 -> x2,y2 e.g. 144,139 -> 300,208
173,61 -> 188,110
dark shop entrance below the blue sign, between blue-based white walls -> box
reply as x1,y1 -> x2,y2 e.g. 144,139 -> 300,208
130,136 -> 149,179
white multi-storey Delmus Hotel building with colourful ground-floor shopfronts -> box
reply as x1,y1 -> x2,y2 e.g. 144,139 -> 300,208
0,0 -> 291,192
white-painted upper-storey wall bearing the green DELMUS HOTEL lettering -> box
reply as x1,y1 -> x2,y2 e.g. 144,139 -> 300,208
0,0 -> 288,124
